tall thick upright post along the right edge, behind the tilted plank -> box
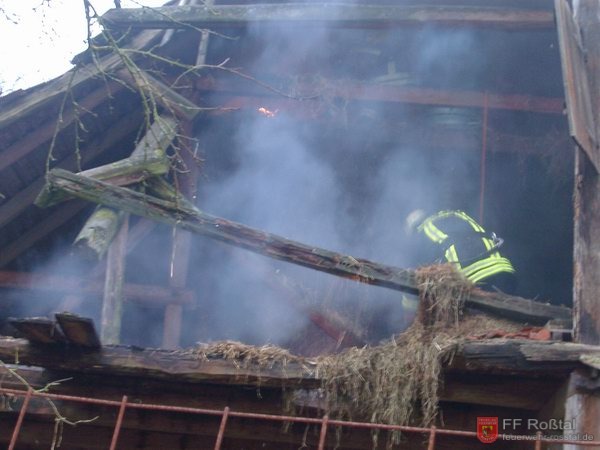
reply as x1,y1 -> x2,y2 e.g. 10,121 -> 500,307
557,0 -> 600,444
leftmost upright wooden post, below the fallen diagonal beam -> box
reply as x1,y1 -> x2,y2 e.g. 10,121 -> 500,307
100,215 -> 129,344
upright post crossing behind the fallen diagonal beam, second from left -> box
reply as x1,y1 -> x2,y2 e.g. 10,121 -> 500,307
162,122 -> 198,348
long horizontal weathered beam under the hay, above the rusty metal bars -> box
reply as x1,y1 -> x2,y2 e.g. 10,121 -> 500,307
0,337 -> 600,382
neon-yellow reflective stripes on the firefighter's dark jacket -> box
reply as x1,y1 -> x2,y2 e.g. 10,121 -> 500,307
418,211 -> 515,283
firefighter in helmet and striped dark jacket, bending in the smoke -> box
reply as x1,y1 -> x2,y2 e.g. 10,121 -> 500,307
406,210 -> 516,294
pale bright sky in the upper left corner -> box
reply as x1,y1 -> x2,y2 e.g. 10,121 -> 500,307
0,0 -> 166,94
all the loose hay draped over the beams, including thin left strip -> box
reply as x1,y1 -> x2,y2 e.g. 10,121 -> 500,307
186,265 -> 521,448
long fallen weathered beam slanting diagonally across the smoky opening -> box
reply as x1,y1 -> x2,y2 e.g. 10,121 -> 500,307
48,169 -> 571,324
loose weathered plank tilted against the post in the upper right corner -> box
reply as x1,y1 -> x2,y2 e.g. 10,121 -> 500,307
554,0 -> 600,171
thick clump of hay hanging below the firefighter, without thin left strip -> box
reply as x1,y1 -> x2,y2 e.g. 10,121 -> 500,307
317,265 -> 473,443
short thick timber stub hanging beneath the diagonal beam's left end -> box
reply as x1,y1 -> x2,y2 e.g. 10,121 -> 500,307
73,206 -> 123,260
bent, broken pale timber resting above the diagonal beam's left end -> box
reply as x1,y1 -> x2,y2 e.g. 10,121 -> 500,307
35,116 -> 178,208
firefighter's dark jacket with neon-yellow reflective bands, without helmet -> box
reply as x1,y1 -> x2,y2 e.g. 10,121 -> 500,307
418,211 -> 515,283
